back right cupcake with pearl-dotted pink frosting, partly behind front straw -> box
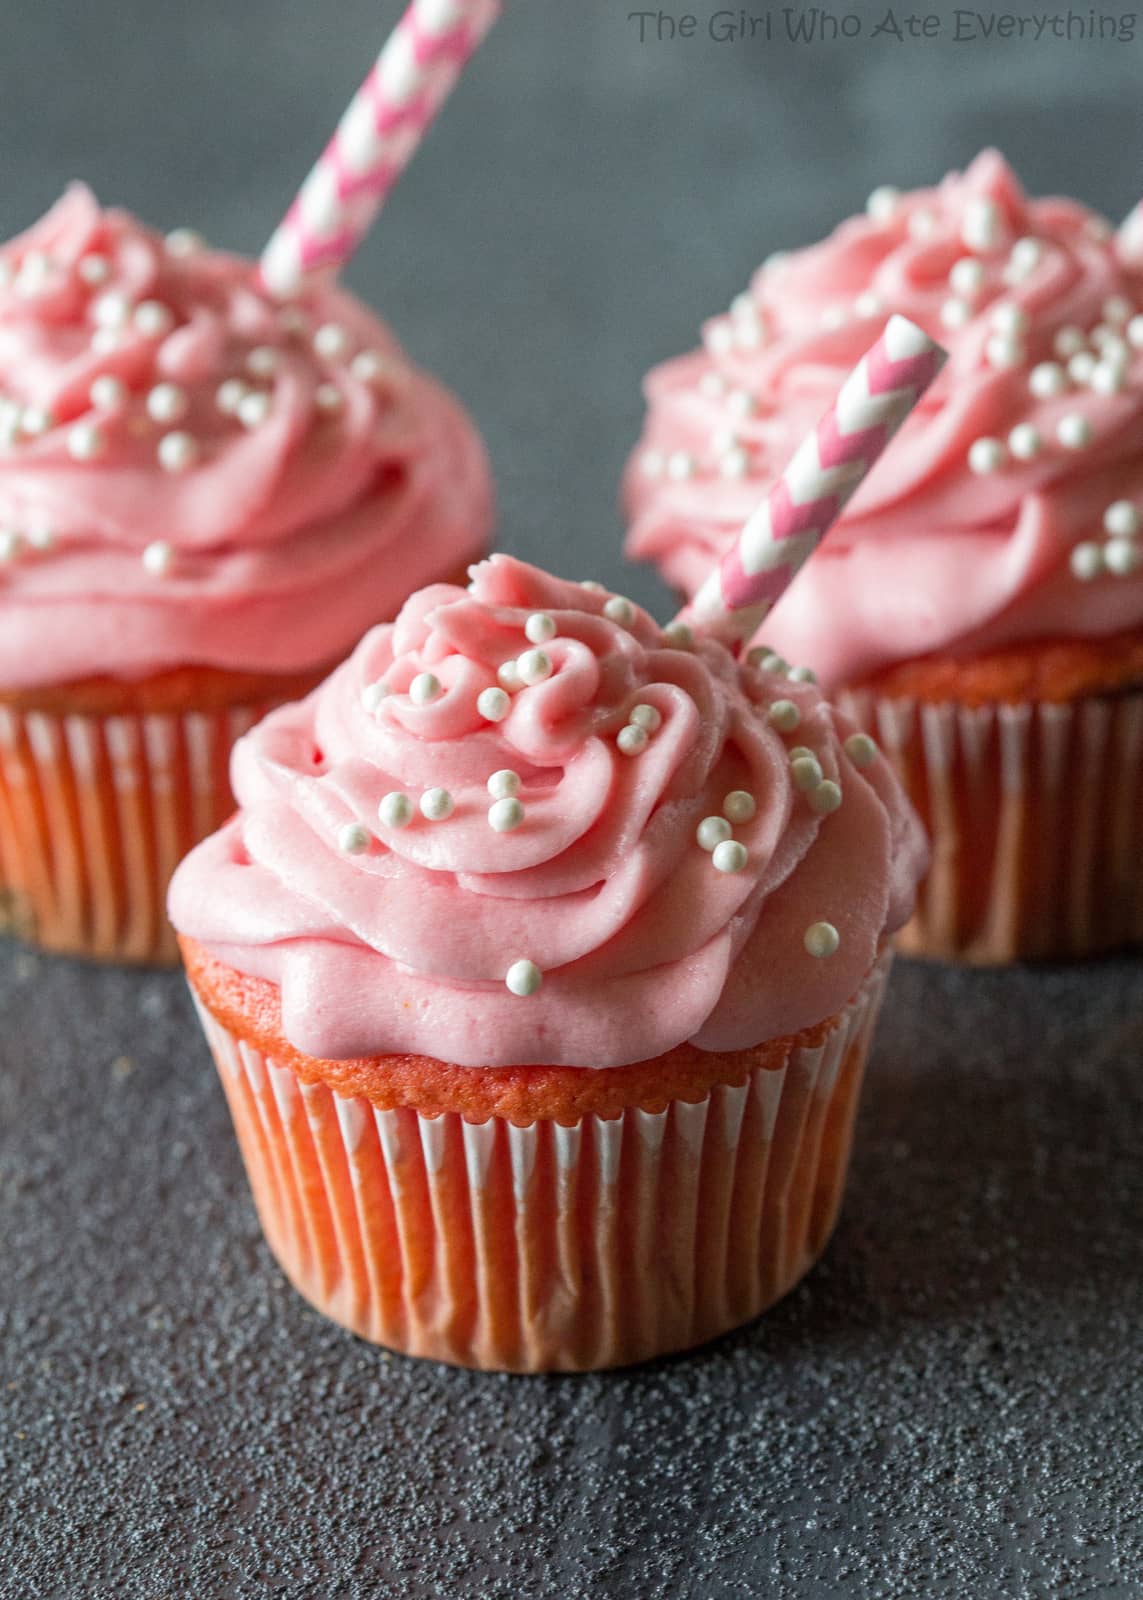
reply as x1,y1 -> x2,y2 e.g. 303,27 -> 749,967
624,154 -> 1143,962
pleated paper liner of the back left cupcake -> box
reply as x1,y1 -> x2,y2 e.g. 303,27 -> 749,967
0,699 -> 272,962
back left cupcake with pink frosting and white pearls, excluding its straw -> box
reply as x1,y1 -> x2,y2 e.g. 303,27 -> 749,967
0,186 -> 491,962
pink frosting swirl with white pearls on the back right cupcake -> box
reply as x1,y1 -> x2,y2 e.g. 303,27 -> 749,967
624,152 -> 1143,686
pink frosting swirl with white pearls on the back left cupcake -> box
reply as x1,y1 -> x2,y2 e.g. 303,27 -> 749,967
0,186 -> 490,688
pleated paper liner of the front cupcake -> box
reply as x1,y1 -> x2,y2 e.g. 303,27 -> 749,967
188,954 -> 890,1371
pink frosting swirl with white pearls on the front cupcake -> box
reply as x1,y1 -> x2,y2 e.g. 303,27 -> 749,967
170,555 -> 925,1067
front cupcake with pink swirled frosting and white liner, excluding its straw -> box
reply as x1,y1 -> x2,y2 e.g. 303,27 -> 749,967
170,555 -> 925,1371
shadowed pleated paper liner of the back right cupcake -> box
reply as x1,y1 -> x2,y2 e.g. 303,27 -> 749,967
837,690 -> 1143,965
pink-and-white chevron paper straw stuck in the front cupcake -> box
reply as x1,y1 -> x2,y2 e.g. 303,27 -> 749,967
677,317 -> 946,643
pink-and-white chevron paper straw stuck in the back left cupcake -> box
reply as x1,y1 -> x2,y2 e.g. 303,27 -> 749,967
261,0 -> 501,298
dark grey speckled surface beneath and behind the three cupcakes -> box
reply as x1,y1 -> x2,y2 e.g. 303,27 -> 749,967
0,0 -> 1143,1600
